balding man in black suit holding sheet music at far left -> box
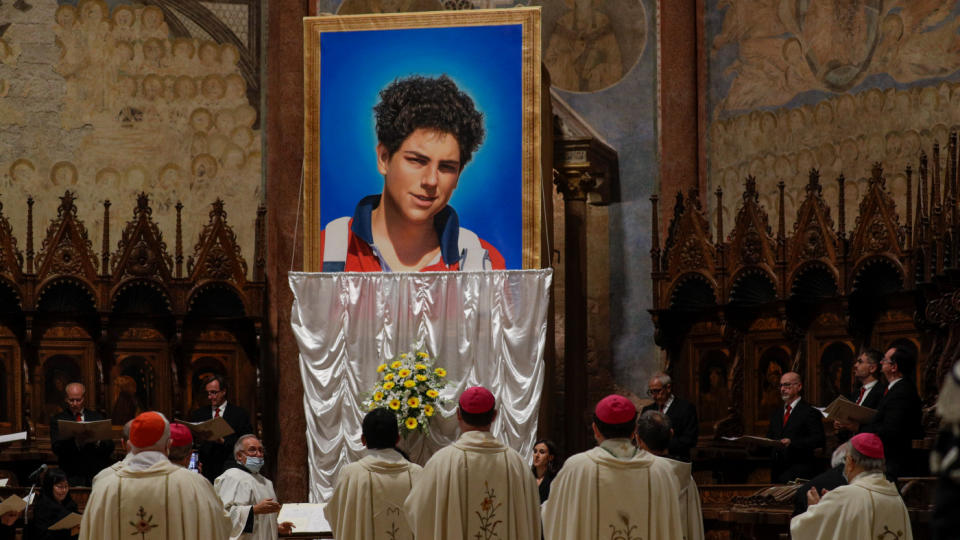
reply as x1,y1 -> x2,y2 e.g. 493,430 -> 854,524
50,382 -> 114,486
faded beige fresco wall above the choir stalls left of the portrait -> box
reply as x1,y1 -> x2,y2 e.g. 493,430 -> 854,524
0,0 -> 262,272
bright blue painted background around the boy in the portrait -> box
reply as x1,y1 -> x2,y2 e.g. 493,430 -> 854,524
320,24 -> 523,268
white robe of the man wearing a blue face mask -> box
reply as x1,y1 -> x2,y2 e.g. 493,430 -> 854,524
213,467 -> 279,540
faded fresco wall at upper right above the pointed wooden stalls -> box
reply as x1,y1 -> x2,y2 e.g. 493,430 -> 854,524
705,0 -> 960,239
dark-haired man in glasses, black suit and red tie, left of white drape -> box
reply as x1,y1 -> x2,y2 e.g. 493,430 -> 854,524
190,375 -> 254,482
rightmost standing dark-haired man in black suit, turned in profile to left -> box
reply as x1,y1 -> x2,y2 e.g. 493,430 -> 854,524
855,347 -> 923,480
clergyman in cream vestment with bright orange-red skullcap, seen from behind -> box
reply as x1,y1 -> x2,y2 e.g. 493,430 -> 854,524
80,411 -> 230,540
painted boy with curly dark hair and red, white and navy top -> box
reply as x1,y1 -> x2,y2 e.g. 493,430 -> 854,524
321,75 -> 506,272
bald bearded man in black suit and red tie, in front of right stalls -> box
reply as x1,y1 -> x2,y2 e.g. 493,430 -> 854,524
767,371 -> 826,484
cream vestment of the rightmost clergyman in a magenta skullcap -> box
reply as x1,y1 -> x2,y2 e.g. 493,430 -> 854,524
790,473 -> 913,540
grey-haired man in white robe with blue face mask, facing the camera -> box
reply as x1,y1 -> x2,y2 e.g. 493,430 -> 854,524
213,434 -> 292,540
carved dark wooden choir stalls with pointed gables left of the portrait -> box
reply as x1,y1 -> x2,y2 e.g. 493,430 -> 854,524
0,191 -> 265,458
